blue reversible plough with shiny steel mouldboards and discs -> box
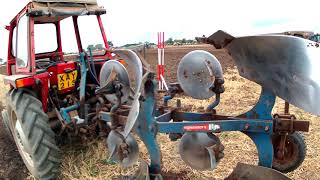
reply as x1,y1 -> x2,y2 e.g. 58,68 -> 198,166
95,31 -> 320,179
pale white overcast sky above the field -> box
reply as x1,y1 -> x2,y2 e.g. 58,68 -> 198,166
0,0 -> 320,59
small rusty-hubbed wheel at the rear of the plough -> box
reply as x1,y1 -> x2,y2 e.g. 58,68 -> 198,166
272,132 -> 307,173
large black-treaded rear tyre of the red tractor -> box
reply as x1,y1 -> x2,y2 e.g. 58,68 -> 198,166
7,89 -> 60,179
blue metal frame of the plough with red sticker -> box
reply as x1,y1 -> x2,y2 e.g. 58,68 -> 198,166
100,79 -> 276,174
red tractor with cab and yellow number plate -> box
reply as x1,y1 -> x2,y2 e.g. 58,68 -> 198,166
2,0 -> 128,179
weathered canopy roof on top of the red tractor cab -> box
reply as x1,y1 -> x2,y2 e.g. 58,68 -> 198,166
10,0 -> 106,23
